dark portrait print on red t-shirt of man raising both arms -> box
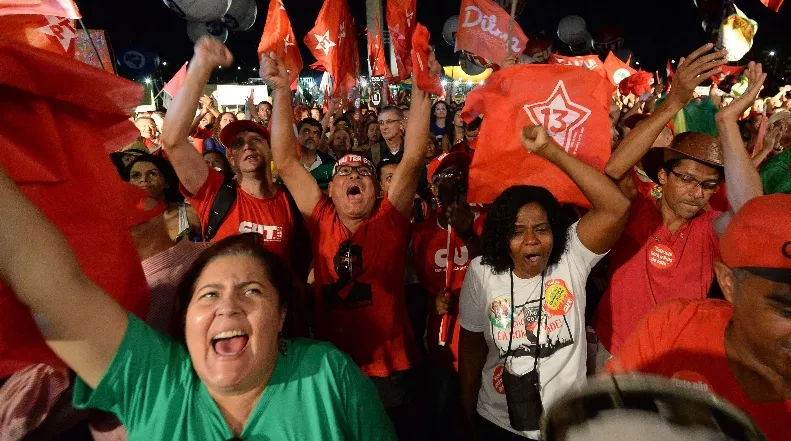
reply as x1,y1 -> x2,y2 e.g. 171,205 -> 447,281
322,240 -> 373,309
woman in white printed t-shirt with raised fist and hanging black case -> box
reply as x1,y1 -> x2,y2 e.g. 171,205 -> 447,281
459,126 -> 629,440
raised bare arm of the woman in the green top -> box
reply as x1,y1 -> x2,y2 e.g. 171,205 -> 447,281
0,168 -> 128,387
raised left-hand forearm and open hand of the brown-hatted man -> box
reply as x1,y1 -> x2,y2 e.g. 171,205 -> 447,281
604,44 -> 727,190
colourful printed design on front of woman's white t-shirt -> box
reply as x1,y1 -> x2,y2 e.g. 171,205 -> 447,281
488,279 -> 574,375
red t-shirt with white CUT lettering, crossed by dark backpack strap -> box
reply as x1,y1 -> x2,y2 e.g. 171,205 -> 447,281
181,168 -> 295,262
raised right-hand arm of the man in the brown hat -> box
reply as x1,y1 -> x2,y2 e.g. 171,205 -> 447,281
714,61 -> 766,235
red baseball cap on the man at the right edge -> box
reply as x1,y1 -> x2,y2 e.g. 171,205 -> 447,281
720,194 -> 791,283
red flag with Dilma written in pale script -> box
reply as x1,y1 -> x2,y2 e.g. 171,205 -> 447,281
456,0 -> 527,65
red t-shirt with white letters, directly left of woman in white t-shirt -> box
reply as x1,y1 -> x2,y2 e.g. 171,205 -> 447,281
411,213 -> 470,372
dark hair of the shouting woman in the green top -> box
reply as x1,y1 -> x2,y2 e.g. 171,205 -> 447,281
176,233 -> 296,343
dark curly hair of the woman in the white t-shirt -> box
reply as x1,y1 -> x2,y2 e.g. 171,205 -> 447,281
481,185 -> 570,274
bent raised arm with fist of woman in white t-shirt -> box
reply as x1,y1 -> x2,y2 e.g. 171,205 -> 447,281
522,126 -> 629,254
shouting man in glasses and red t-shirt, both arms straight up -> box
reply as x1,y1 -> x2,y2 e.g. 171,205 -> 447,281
260,49 -> 439,429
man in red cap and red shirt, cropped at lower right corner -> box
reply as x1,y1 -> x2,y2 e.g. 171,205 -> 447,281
607,194 -> 791,441
